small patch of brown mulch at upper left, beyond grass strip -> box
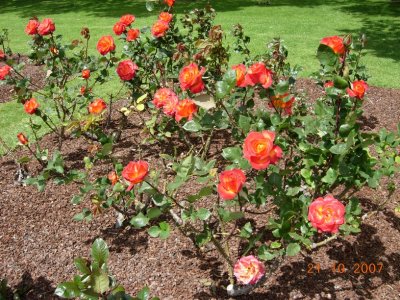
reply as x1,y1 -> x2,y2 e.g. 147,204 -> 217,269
0,54 -> 46,103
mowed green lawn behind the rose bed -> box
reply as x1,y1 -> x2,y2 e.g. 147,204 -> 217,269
0,0 -> 400,152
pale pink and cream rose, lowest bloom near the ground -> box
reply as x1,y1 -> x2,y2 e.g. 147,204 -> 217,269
233,255 -> 265,284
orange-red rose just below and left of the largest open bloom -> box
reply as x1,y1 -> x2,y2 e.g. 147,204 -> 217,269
217,169 -> 246,200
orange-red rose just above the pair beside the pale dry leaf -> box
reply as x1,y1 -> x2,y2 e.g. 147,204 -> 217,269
179,63 -> 206,94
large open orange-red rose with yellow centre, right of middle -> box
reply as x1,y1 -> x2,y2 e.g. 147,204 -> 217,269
243,130 -> 282,170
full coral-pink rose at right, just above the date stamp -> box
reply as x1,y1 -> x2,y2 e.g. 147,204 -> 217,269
308,195 -> 345,233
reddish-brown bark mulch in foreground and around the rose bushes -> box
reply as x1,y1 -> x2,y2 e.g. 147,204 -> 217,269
0,80 -> 400,300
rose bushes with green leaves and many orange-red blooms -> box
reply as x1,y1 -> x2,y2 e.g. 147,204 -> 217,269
0,1 -> 400,295
